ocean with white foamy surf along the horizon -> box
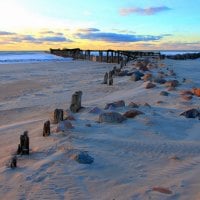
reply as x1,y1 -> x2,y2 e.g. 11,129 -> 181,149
0,50 -> 199,64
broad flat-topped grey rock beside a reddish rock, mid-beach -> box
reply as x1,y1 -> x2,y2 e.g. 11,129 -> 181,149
99,112 -> 126,123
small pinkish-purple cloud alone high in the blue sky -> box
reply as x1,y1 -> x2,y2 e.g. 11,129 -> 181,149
119,6 -> 171,16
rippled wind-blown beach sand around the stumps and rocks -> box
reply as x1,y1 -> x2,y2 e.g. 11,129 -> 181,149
0,60 -> 200,200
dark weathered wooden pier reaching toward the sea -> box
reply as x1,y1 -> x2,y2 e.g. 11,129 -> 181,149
50,48 -> 160,64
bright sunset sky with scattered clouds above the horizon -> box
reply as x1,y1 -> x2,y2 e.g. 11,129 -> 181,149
0,0 -> 200,51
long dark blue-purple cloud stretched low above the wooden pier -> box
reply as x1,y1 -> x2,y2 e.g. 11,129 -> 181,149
76,32 -> 164,43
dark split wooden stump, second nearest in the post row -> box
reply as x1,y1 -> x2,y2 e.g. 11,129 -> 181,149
17,131 -> 29,155
